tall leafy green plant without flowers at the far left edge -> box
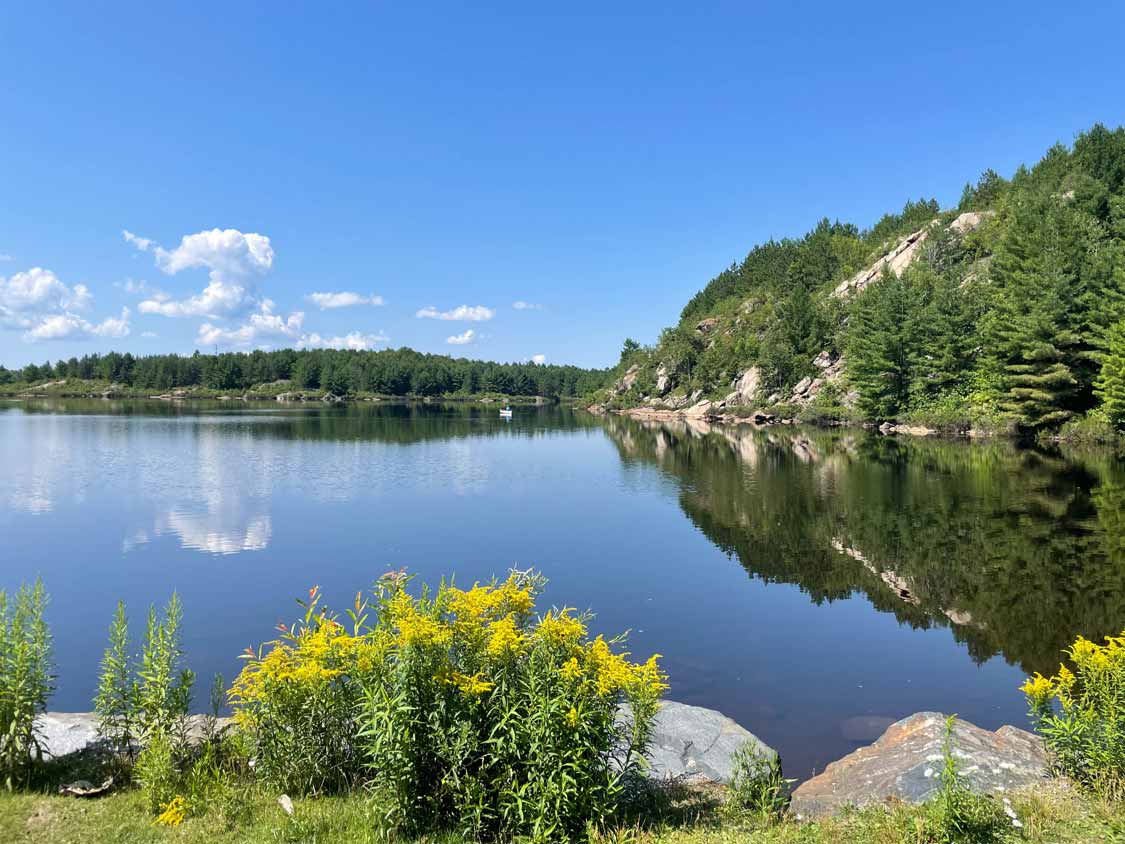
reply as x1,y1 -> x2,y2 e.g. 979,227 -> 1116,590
0,581 -> 54,790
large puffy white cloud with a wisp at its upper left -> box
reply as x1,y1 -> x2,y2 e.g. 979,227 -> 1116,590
122,228 -> 273,320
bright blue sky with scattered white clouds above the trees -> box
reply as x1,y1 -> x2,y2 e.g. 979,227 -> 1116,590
0,2 -> 1125,366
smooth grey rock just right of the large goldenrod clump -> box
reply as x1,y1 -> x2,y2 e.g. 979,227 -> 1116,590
649,700 -> 777,782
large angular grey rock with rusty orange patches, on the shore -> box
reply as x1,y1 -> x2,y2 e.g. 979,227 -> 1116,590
790,712 -> 1047,818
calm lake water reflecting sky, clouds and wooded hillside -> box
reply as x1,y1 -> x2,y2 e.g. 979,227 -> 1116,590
0,401 -> 1125,778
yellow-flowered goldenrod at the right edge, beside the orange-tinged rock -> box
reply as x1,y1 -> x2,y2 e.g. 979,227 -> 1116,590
1022,632 -> 1125,798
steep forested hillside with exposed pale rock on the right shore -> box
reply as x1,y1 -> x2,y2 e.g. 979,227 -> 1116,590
602,125 -> 1125,431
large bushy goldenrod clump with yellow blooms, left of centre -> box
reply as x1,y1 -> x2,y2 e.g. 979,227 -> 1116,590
232,574 -> 665,839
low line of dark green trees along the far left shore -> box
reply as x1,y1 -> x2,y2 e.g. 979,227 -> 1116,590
0,348 -> 608,397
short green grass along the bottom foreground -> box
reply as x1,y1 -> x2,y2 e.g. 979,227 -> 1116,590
0,782 -> 1125,844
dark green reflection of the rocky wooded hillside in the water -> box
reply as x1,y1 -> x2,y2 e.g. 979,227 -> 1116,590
606,416 -> 1125,672
